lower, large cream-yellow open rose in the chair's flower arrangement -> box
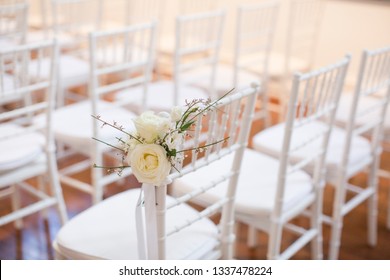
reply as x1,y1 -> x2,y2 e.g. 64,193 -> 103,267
127,144 -> 171,186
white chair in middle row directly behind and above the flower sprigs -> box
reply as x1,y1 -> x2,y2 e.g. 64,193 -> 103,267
117,11 -> 224,110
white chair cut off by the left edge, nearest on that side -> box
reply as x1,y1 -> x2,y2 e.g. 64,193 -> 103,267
0,42 -> 67,228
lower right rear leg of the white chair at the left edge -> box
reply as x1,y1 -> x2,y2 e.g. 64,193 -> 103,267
48,152 -> 68,224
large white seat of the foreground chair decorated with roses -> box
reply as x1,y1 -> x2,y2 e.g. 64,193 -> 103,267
56,189 -> 218,260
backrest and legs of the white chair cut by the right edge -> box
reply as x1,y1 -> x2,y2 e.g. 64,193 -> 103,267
330,47 -> 390,258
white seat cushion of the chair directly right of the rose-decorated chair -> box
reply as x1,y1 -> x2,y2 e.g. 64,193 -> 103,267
173,149 -> 312,216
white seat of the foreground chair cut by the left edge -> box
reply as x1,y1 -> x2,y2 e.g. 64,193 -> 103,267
0,124 -> 45,173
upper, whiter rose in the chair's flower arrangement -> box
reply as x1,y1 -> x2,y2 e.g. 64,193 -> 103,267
134,111 -> 171,144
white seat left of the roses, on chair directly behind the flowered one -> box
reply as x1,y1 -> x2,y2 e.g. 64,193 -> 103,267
46,101 -> 135,154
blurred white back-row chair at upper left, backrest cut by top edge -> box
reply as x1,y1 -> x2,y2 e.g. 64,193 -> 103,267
29,0 -> 101,107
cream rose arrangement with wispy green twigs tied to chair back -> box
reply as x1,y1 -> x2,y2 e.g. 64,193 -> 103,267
92,90 -> 232,186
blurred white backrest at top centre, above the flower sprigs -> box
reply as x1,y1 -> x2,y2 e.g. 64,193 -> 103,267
174,10 -> 225,100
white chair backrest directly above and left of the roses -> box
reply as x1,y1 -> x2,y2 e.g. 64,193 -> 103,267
89,22 -> 157,132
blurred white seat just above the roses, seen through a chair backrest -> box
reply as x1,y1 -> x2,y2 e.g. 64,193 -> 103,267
116,81 -> 208,111
